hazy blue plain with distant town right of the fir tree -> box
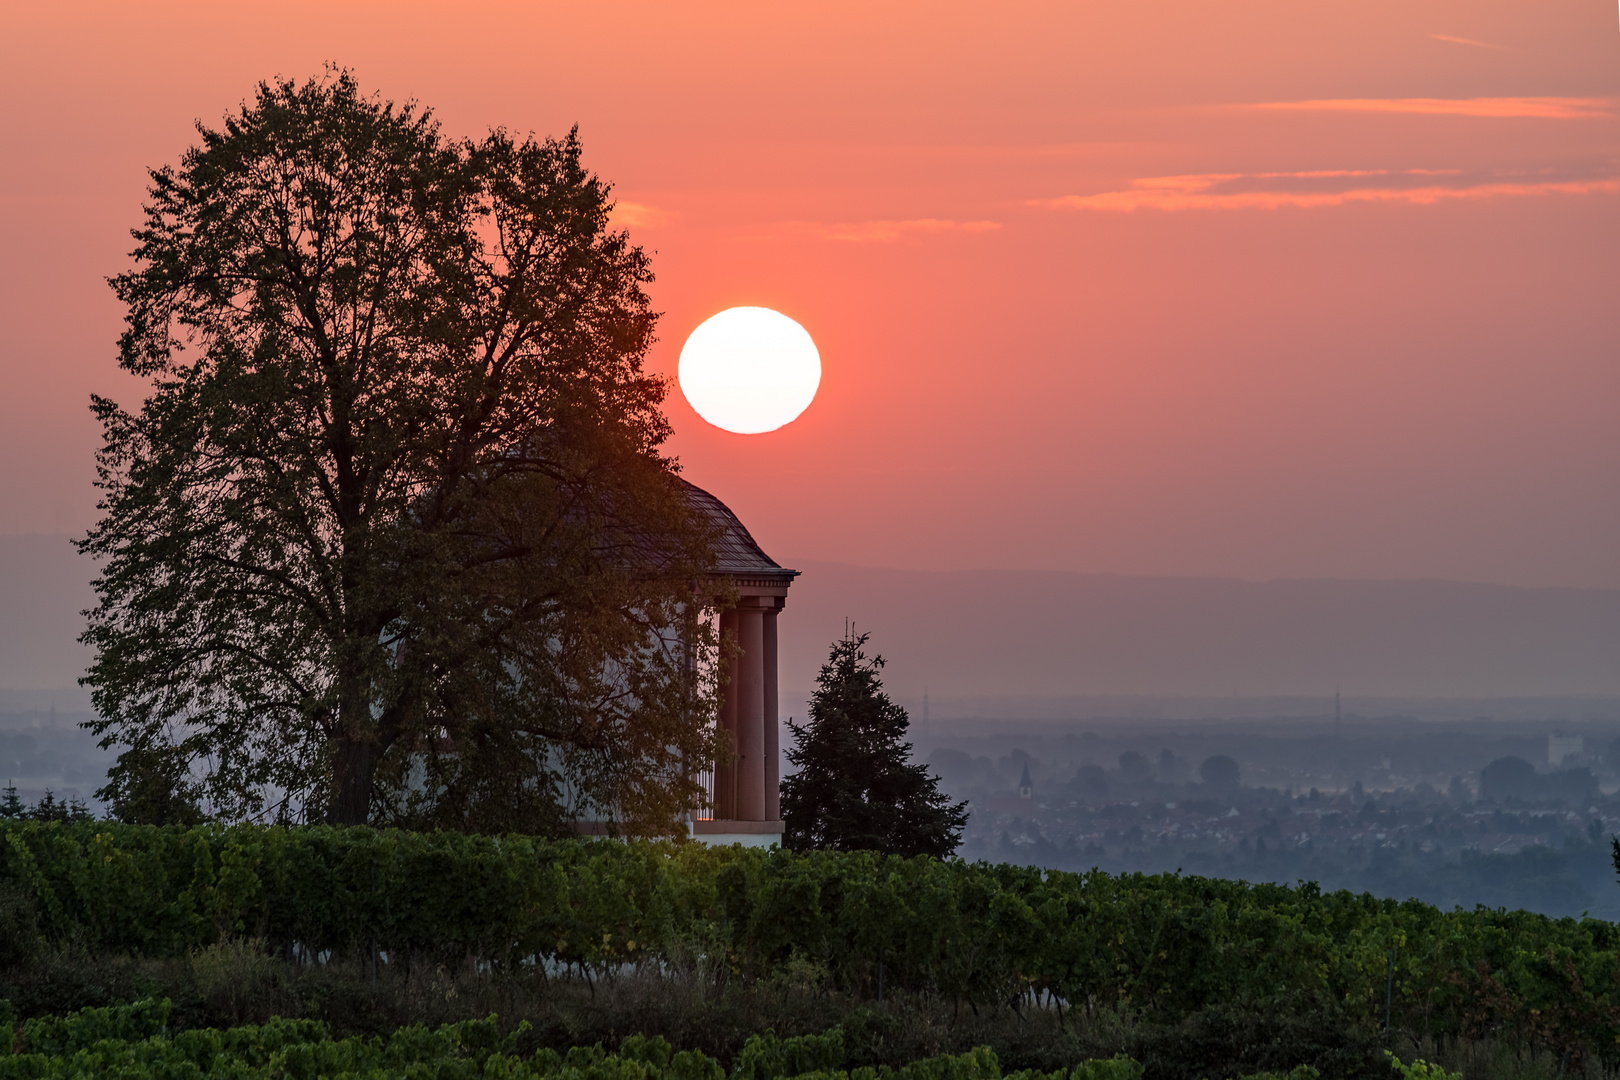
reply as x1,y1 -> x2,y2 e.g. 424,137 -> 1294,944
919,716 -> 1620,920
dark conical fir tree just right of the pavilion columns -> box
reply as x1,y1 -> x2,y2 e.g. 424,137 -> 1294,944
782,633 -> 967,858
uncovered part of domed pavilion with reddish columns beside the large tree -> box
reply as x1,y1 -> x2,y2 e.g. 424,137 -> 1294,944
682,481 -> 799,847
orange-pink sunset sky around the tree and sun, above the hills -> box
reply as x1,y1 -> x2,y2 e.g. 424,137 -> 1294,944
0,0 -> 1620,588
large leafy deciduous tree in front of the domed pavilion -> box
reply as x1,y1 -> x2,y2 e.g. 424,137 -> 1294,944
81,71 -> 716,832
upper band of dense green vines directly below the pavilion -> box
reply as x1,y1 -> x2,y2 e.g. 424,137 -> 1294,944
0,823 -> 1620,1080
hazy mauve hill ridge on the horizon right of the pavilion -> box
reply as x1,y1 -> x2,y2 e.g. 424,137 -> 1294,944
781,559 -> 1620,698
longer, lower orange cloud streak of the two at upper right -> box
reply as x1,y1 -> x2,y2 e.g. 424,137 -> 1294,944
1027,168 -> 1620,214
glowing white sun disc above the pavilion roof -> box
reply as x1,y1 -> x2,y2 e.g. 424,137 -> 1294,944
679,308 -> 821,436
